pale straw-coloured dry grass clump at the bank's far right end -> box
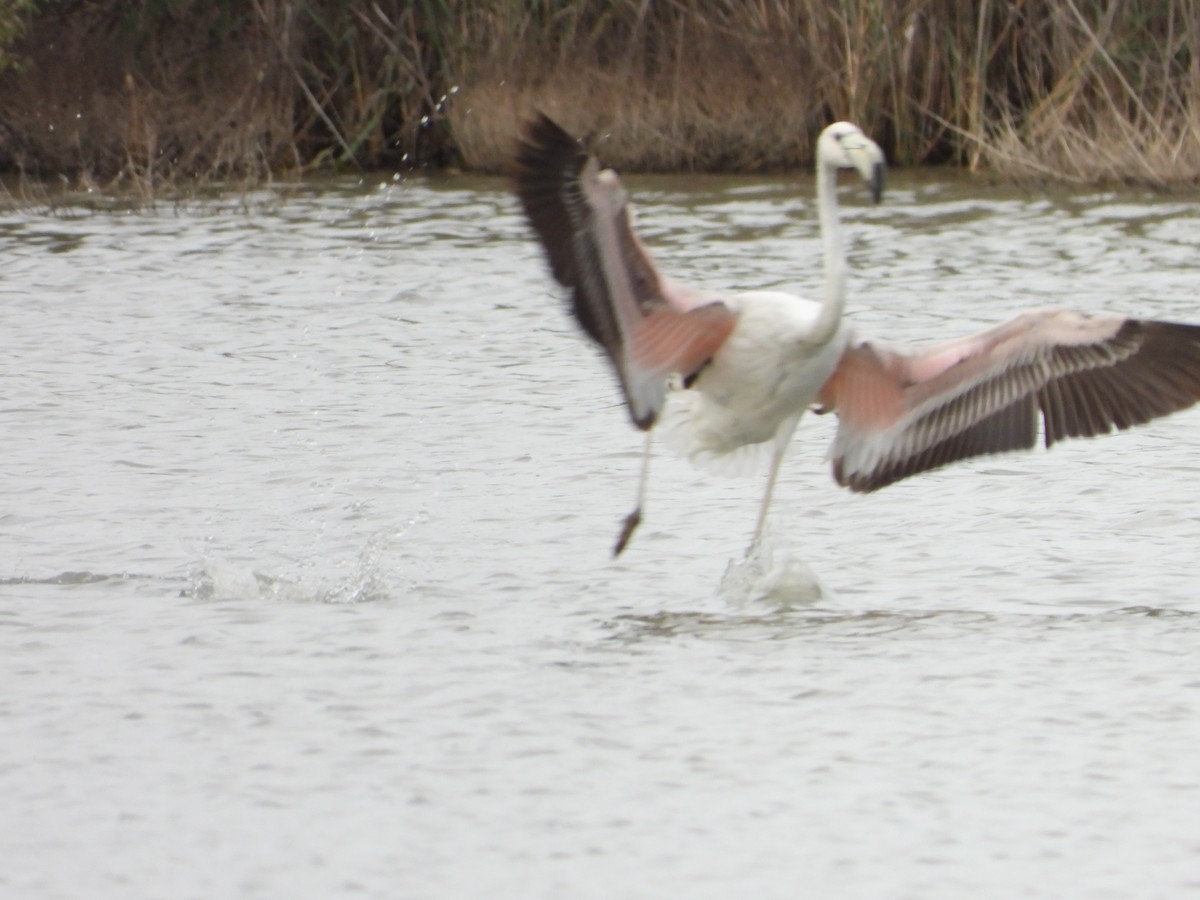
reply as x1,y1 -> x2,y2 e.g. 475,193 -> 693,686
970,0 -> 1200,185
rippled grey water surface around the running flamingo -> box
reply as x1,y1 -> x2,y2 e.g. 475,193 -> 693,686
0,173 -> 1200,898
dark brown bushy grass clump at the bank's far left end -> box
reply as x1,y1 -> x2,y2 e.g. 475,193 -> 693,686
0,4 -> 295,191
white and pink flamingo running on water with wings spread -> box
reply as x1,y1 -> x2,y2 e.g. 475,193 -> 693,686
514,114 -> 1200,556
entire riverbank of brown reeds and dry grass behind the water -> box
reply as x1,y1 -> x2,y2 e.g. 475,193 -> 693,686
0,0 -> 1200,193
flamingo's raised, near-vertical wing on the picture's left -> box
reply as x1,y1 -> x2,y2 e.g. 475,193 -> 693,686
515,115 -> 736,430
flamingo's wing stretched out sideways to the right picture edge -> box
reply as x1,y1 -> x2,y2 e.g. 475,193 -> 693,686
821,310 -> 1200,491
